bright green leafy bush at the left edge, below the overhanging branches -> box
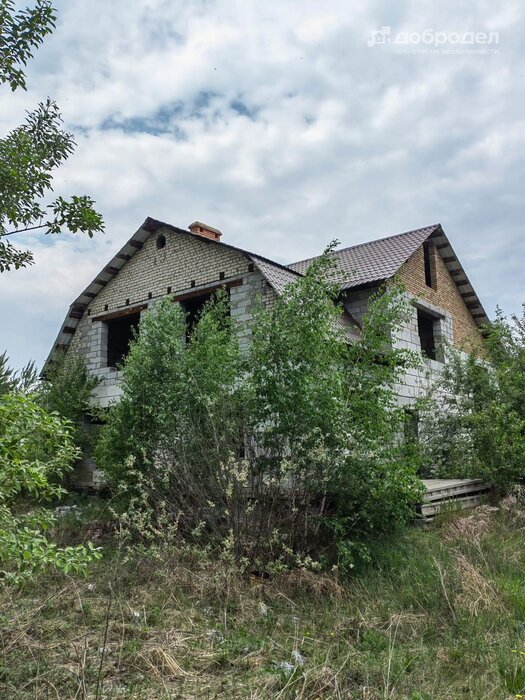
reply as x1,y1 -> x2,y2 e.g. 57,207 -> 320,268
0,393 -> 100,582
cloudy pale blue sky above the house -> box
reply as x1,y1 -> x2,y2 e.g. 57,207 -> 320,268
0,0 -> 525,367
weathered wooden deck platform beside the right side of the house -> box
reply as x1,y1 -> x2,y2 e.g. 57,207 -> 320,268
416,479 -> 491,525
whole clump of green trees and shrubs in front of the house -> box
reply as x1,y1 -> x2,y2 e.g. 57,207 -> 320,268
96,250 -> 420,568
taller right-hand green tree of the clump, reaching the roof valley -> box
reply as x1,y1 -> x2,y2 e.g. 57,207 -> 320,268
249,248 -> 421,566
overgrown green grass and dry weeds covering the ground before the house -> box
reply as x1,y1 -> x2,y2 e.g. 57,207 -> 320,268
0,498 -> 525,700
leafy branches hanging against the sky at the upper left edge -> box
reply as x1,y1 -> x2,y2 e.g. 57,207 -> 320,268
0,0 -> 104,272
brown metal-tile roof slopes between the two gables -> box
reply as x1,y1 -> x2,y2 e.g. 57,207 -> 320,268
288,224 -> 441,289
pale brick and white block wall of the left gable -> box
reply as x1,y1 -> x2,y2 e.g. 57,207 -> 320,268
70,230 -> 276,407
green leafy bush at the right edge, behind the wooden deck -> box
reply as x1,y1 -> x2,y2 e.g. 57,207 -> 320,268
421,312 -> 525,490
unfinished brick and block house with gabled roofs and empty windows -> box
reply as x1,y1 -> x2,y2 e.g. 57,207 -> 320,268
44,218 -> 487,487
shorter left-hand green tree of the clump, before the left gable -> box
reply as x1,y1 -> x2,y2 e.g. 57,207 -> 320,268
95,293 -> 244,541
